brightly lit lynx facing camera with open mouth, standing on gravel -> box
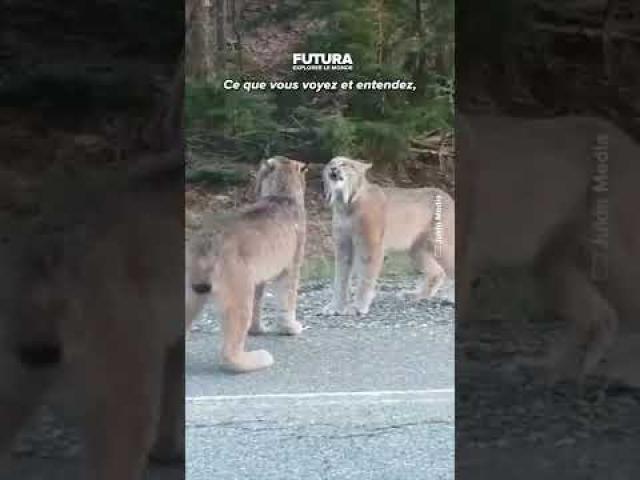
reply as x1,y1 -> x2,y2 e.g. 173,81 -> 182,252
323,157 -> 455,314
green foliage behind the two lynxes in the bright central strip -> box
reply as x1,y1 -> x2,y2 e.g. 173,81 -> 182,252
186,0 -> 454,167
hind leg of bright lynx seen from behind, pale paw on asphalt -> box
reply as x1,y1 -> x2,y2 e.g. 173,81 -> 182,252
218,272 -> 273,373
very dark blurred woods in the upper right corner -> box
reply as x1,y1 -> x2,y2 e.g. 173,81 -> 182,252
456,0 -> 640,138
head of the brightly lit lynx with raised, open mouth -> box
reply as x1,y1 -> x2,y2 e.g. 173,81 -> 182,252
322,157 -> 372,205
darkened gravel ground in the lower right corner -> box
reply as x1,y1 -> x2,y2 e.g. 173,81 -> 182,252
456,312 -> 640,480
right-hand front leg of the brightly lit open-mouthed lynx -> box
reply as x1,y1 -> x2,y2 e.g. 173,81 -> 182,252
353,242 -> 384,315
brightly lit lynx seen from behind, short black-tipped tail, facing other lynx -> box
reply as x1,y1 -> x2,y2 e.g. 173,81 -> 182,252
186,157 -> 306,372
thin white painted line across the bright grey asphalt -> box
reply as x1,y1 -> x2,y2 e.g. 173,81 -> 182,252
186,388 -> 455,404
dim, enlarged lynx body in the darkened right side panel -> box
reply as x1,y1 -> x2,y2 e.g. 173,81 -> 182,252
456,115 -> 640,378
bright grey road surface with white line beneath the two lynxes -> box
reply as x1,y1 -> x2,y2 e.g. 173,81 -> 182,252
187,281 -> 454,480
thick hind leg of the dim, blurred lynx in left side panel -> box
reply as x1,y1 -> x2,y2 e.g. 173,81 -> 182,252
79,312 -> 164,480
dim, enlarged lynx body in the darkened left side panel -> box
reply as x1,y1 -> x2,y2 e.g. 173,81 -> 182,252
0,175 -> 184,480
